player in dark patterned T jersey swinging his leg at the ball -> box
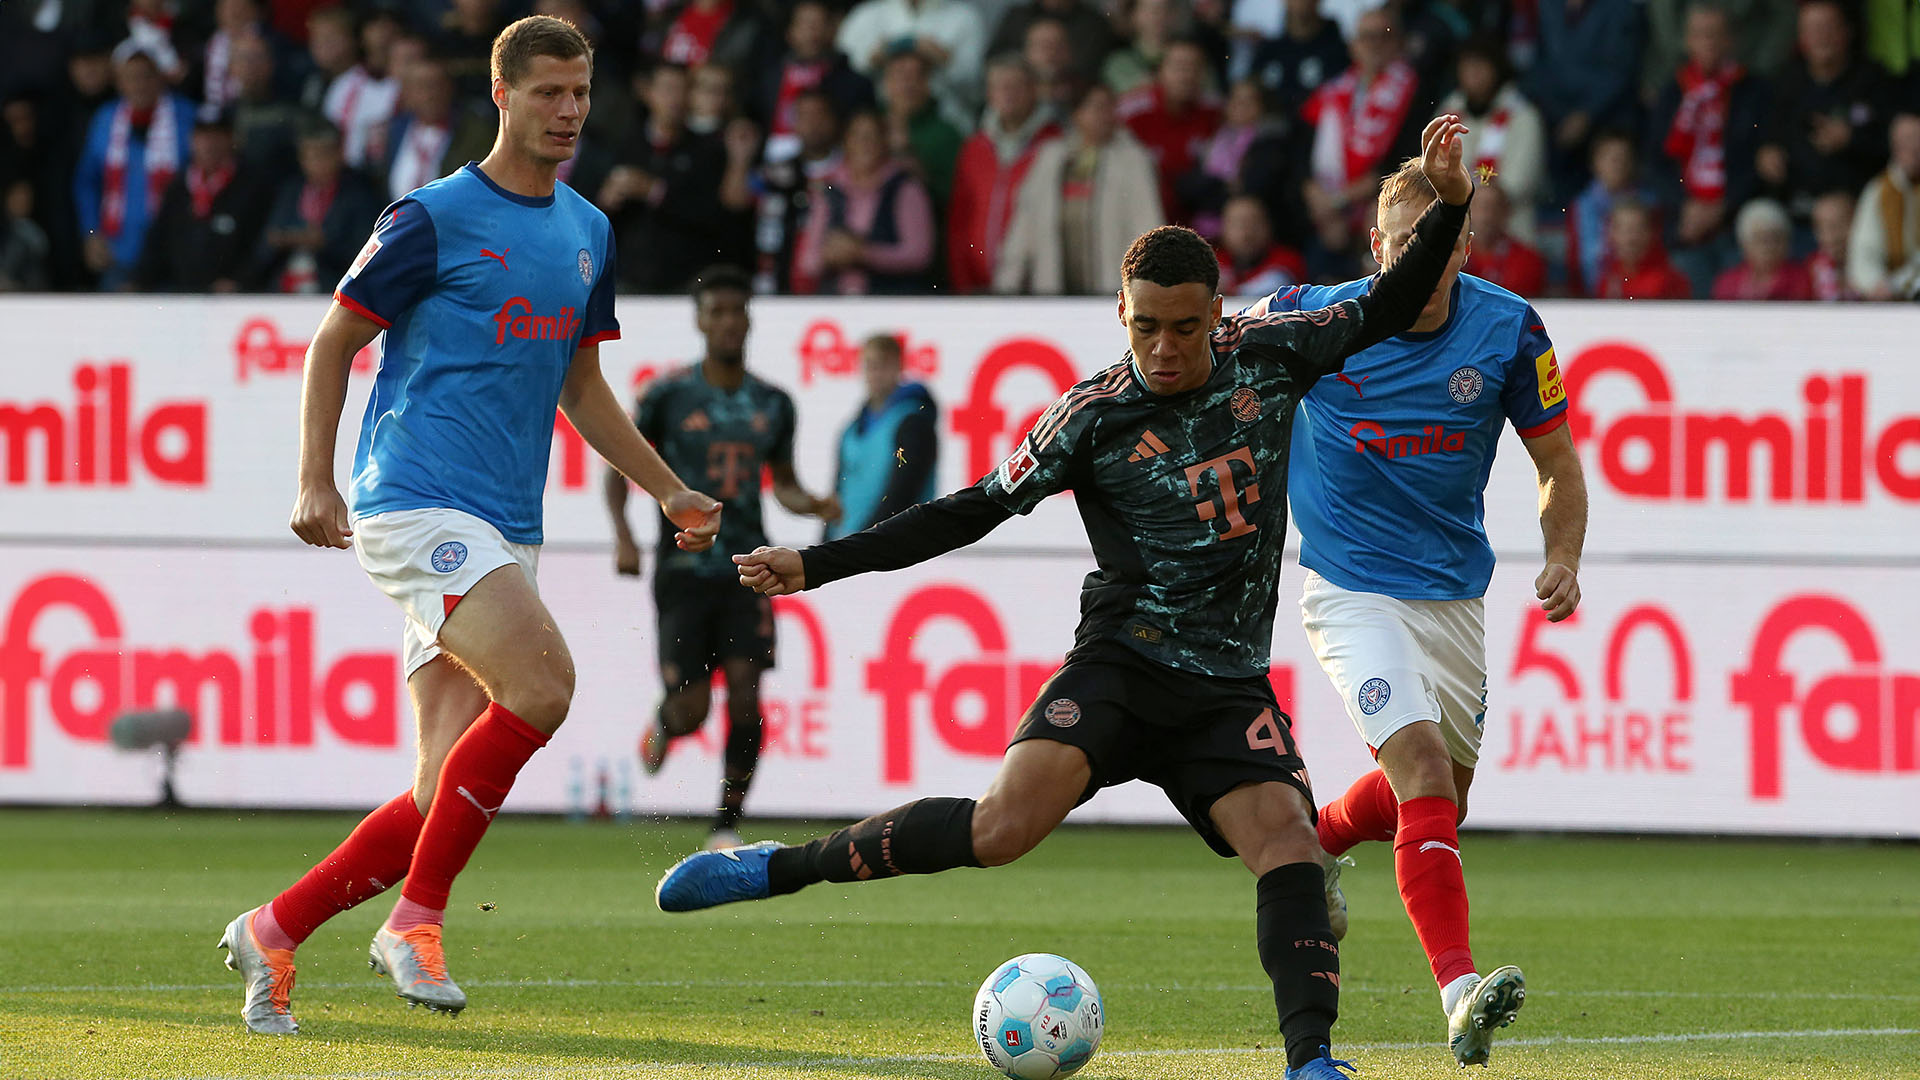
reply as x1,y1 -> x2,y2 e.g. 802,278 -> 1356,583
655,115 -> 1473,1080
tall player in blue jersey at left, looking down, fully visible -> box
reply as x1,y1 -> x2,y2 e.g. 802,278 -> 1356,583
221,17 -> 720,1034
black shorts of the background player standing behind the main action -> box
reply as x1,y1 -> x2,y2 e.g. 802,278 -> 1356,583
653,575 -> 774,694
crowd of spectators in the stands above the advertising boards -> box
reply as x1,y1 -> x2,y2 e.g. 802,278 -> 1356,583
0,0 -> 1920,300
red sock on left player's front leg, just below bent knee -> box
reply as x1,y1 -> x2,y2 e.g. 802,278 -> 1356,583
399,701 -> 547,911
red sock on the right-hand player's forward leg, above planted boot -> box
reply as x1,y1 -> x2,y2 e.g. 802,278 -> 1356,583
1394,796 -> 1473,986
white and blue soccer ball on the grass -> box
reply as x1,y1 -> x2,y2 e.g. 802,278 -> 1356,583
973,953 -> 1106,1080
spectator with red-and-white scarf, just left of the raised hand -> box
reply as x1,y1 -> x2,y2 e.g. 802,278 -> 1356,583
1302,12 -> 1425,248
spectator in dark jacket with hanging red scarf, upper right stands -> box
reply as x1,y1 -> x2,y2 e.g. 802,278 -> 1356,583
1647,0 -> 1764,292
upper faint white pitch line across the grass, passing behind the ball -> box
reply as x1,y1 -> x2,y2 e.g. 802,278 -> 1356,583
0,978 -> 1920,1001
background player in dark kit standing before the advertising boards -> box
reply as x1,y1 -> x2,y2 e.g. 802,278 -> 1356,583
607,267 -> 839,847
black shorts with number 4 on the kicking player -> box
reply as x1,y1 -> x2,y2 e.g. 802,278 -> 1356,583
1014,642 -> 1313,859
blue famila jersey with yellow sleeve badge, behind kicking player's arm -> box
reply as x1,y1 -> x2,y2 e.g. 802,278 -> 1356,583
1256,275 -> 1567,600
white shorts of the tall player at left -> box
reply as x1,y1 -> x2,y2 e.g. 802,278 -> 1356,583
353,507 -> 540,678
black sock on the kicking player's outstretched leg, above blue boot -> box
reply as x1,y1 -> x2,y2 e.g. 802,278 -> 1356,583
766,799 -> 975,895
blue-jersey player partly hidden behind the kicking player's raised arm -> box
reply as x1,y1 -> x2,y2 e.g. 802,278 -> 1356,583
1250,161 -> 1586,1065
